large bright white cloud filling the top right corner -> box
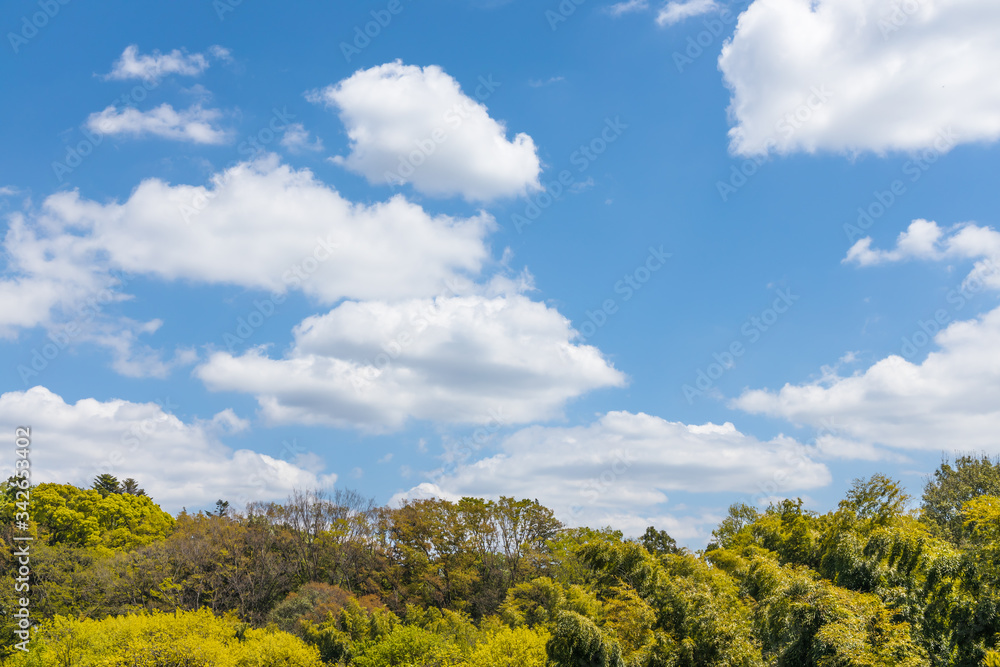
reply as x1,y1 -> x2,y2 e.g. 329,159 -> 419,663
719,0 -> 1000,154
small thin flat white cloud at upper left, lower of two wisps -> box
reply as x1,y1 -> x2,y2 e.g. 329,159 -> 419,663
87,104 -> 232,144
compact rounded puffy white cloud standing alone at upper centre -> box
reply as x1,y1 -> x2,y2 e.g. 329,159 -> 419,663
310,61 -> 541,201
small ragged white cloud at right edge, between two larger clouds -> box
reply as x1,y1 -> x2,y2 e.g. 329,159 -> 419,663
843,220 -> 1000,289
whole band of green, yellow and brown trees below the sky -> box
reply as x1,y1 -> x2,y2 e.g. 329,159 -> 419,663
0,455 -> 1000,667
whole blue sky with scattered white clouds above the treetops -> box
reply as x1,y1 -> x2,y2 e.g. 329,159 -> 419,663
0,0 -> 1000,546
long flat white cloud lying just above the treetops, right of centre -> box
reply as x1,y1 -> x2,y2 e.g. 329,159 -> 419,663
397,412 -> 830,537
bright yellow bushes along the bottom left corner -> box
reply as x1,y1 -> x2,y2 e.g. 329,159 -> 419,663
7,609 -> 322,667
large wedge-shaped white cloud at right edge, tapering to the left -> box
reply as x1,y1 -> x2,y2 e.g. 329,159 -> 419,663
733,309 -> 1000,453
